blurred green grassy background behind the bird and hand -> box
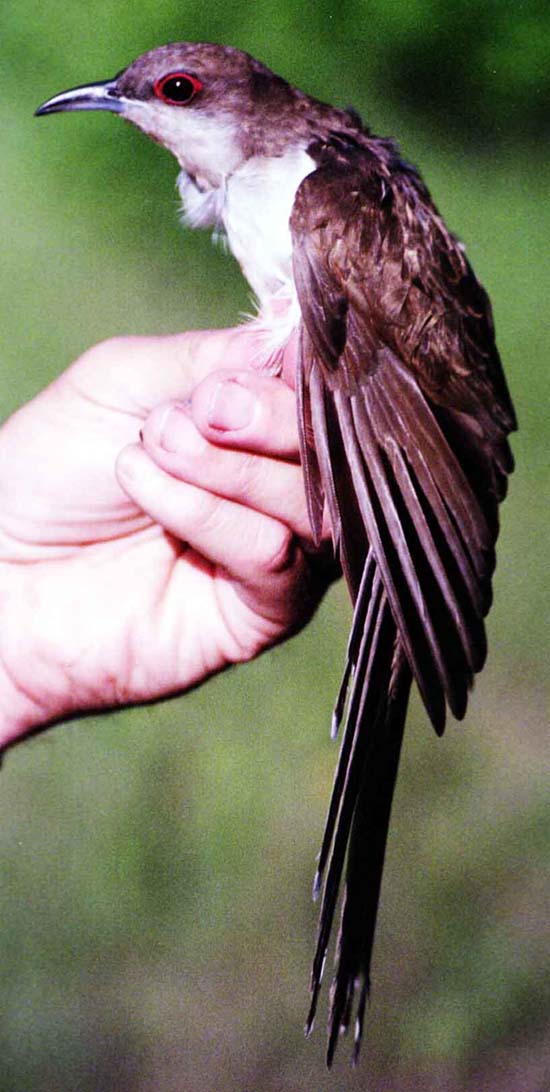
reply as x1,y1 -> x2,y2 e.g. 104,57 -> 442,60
0,0 -> 550,1092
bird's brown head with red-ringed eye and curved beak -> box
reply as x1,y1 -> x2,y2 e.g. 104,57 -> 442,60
36,43 -> 306,186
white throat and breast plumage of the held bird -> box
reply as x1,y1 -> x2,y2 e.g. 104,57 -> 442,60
124,100 -> 316,372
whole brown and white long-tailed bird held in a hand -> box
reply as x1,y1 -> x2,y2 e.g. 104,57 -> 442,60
36,41 -> 517,1066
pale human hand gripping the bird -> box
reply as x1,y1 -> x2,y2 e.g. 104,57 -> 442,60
0,328 -> 335,748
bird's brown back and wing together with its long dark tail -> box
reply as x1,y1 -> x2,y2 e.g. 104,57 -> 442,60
290,134 -> 515,1061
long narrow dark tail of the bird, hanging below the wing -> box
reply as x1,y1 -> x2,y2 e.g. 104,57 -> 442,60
306,557 -> 411,1066
